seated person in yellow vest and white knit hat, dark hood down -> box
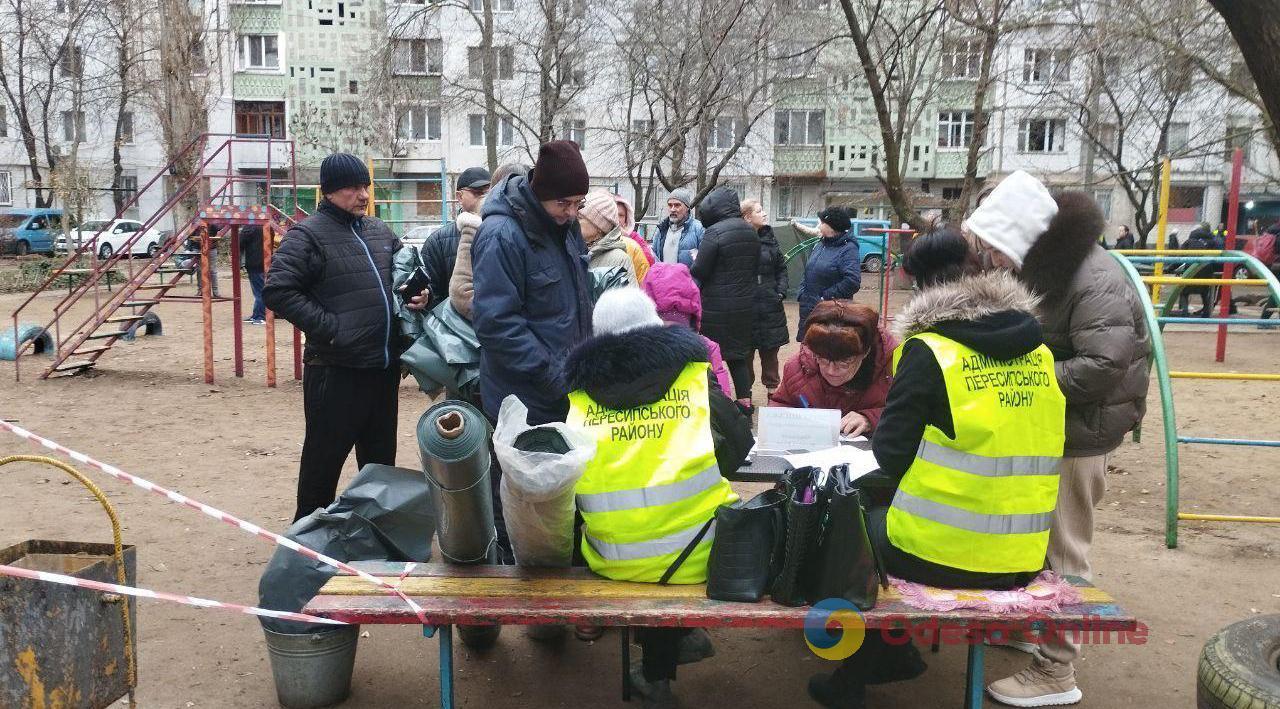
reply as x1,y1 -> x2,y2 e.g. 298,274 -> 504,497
564,288 -> 754,706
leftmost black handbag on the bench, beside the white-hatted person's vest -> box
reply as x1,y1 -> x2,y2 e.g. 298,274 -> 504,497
707,490 -> 786,603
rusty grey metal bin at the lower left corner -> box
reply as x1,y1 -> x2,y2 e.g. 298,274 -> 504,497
0,540 -> 137,709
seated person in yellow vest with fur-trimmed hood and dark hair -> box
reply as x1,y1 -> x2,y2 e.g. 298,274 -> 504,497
809,232 -> 1066,709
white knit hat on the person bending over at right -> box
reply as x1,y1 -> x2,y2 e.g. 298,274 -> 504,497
963,170 -> 1057,269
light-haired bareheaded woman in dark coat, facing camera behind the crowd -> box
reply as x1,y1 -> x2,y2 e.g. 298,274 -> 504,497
742,200 -> 791,395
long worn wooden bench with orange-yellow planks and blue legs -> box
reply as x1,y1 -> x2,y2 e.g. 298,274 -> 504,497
303,562 -> 1138,709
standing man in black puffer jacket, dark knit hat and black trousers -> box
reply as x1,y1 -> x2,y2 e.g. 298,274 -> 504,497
262,154 -> 428,520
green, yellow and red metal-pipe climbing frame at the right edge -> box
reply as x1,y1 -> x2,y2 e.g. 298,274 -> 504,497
1111,148 -> 1280,549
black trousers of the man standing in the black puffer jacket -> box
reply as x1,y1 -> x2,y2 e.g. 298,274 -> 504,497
293,365 -> 399,521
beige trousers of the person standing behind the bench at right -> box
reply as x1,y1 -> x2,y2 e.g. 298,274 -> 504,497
1036,454 -> 1107,674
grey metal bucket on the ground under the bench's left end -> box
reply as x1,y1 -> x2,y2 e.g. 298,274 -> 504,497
262,626 -> 360,709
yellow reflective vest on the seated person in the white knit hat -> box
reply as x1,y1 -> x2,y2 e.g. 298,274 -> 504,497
567,362 -> 737,584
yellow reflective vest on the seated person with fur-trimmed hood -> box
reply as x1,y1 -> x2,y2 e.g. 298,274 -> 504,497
887,333 -> 1066,573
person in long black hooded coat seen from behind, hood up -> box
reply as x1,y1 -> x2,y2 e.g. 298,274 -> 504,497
689,187 -> 760,407
